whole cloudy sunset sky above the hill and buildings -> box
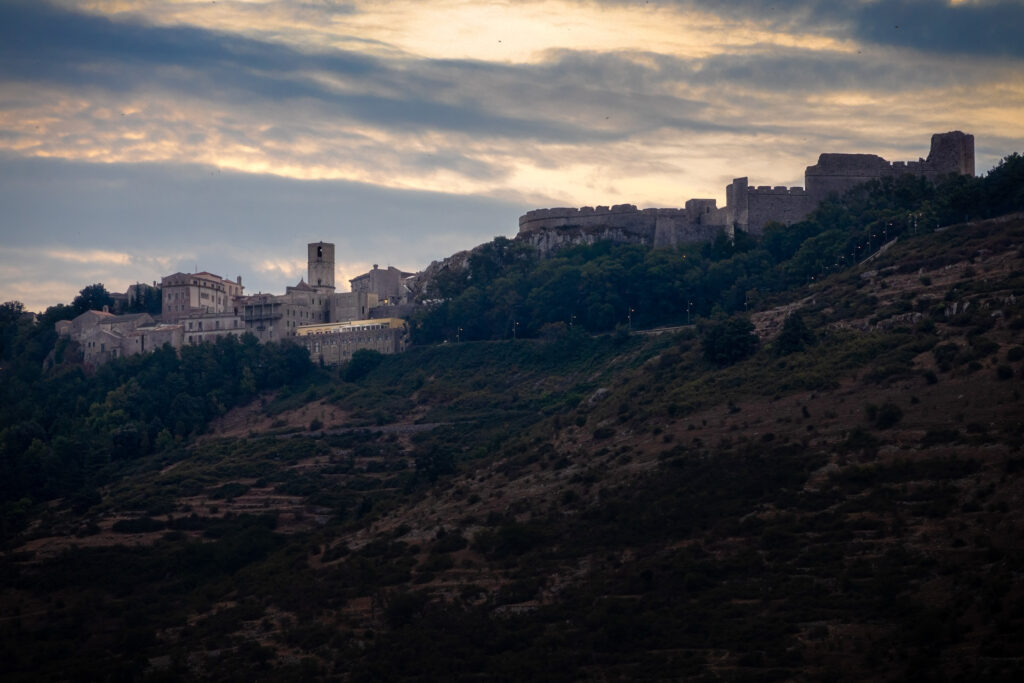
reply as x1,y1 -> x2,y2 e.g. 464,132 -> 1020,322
0,0 -> 1024,311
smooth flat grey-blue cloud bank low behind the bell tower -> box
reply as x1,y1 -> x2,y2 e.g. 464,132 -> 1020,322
0,156 -> 529,310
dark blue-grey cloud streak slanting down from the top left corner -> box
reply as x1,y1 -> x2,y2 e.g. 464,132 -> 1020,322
0,3 -> 614,141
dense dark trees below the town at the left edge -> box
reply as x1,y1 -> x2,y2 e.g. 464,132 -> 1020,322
0,327 -> 312,518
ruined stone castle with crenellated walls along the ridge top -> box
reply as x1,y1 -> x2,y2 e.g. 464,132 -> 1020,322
517,130 -> 974,254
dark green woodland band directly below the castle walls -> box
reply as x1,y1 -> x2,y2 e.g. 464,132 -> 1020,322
413,154 -> 1024,343
